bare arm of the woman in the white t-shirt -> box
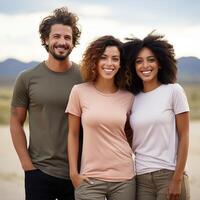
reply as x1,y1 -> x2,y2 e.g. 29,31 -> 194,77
169,112 -> 189,199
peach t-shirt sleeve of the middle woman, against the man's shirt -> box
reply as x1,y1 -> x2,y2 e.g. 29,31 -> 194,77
65,86 -> 81,117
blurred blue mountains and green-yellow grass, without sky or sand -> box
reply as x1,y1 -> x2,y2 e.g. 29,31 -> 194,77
0,57 -> 200,124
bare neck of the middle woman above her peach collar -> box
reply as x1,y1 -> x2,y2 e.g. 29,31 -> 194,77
94,80 -> 118,94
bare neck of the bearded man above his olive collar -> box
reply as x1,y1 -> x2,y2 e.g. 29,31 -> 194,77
45,55 -> 72,72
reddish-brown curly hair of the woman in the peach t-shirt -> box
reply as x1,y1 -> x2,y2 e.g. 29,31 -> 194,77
80,35 -> 125,88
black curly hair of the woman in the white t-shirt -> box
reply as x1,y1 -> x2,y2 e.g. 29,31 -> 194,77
123,31 -> 177,94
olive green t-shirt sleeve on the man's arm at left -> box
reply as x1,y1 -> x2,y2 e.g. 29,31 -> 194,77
11,74 -> 29,108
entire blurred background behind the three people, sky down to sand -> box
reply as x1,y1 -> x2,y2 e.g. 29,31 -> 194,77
0,0 -> 200,200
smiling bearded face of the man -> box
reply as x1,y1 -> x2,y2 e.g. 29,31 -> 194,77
46,24 -> 74,60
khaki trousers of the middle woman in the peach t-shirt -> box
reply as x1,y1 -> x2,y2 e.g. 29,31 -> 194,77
75,178 -> 135,200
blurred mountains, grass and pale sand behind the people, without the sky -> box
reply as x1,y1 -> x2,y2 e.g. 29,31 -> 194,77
0,57 -> 200,200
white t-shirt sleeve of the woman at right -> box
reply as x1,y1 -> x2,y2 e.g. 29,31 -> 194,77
173,84 -> 190,114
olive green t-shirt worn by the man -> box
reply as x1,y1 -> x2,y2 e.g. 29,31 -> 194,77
12,62 -> 82,179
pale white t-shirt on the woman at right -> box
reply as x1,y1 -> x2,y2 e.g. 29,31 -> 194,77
130,83 -> 189,174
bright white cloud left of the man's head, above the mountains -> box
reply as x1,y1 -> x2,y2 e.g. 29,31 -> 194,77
0,13 -> 46,61
